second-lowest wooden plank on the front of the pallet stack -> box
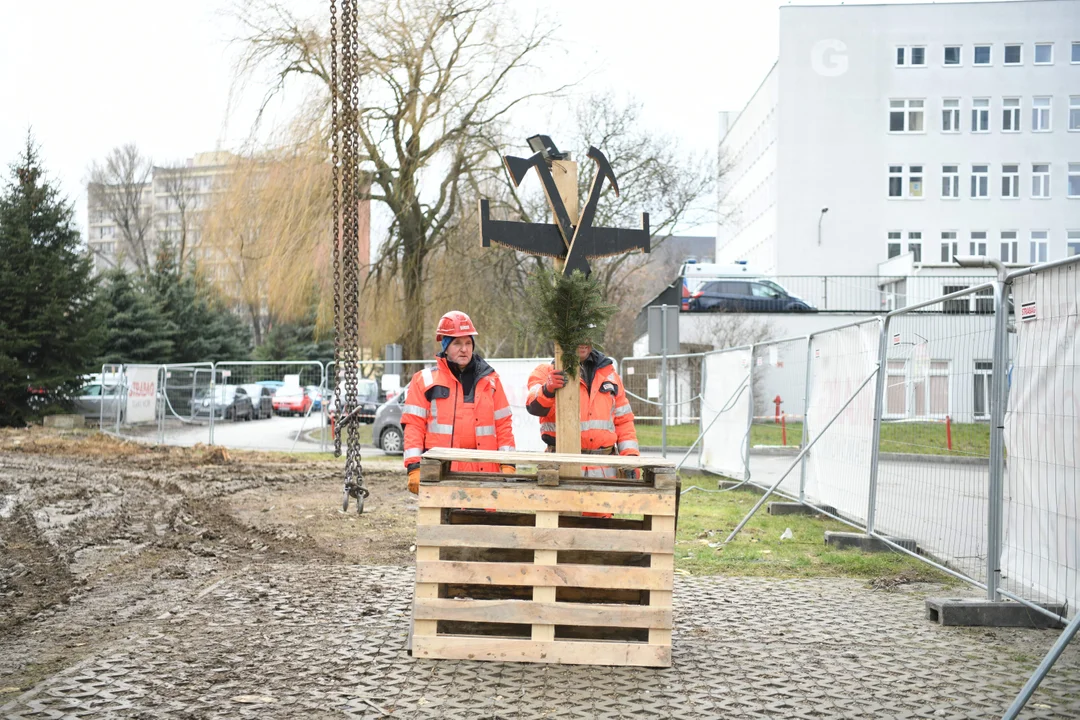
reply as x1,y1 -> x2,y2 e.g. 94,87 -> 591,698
416,590 -> 672,629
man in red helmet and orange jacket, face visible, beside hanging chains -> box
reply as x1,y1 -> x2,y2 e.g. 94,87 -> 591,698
402,310 -> 516,493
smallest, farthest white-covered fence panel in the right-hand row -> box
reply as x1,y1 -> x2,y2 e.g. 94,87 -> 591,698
700,347 -> 753,480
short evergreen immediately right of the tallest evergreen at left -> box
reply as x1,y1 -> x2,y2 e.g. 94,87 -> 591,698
100,268 -> 176,363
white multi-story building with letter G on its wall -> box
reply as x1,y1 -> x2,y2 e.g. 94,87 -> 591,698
716,0 -> 1080,275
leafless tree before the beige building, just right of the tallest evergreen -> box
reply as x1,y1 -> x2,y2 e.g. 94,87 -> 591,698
89,144 -> 157,275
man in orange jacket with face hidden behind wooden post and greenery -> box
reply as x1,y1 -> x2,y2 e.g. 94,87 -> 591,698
525,345 -> 640,477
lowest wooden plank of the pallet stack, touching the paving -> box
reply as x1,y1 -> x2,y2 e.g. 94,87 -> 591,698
413,635 -> 672,667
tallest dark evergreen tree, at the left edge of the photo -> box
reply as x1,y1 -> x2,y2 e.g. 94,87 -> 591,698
0,136 -> 102,426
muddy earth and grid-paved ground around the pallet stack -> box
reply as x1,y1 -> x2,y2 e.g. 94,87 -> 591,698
0,429 -> 1080,719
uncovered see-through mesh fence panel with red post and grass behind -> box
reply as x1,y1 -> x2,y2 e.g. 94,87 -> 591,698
873,297 -> 995,582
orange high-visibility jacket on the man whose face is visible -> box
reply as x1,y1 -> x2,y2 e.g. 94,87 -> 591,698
402,355 -> 514,473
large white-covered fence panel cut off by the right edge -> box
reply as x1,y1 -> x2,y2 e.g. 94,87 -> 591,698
1001,262 -> 1080,613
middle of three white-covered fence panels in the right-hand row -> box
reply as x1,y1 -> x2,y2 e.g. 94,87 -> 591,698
804,318 -> 881,522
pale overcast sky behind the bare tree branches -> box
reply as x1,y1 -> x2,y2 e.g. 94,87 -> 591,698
0,0 -> 1002,240
